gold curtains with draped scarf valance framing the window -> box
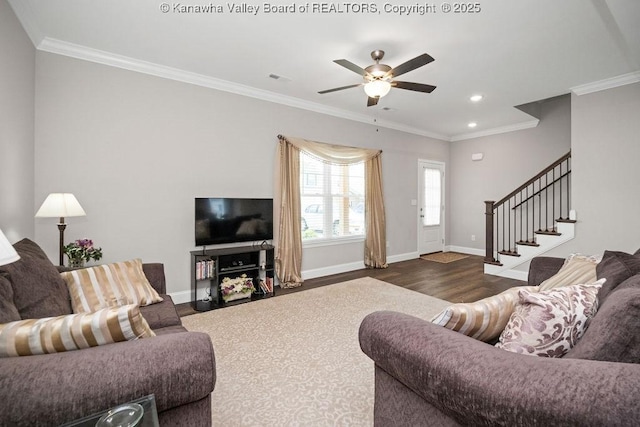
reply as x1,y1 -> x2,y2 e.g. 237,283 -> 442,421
274,135 -> 387,288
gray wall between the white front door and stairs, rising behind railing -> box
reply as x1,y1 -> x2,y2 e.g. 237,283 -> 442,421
449,95 -> 571,253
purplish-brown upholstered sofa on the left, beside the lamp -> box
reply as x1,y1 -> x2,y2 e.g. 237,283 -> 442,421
0,239 -> 216,426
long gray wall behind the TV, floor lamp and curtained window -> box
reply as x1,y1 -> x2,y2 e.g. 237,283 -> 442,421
35,52 -> 448,298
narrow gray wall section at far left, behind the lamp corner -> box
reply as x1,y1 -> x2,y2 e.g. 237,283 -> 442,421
0,0 -> 35,243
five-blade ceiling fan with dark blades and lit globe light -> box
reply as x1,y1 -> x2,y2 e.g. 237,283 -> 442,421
318,50 -> 436,107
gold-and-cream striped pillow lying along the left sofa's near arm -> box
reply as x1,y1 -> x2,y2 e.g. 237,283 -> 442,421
0,304 -> 156,357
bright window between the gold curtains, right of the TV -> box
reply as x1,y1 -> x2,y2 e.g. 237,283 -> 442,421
300,152 -> 364,241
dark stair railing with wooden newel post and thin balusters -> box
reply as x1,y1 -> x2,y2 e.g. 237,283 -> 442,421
484,151 -> 571,265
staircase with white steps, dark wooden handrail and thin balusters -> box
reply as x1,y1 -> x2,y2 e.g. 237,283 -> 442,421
484,152 -> 576,278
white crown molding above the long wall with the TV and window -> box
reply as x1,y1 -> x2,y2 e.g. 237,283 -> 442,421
38,37 -> 449,141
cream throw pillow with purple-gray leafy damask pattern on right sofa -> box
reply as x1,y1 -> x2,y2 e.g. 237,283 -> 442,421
496,280 -> 604,357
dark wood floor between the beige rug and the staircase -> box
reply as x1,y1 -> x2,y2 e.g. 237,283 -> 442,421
177,255 -> 523,316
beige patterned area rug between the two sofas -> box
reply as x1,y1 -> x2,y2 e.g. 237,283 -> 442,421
182,277 -> 450,427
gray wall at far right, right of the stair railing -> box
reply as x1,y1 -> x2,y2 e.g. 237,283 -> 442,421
550,83 -> 640,257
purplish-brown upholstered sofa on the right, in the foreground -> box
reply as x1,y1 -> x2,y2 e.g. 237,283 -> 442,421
360,251 -> 640,426
